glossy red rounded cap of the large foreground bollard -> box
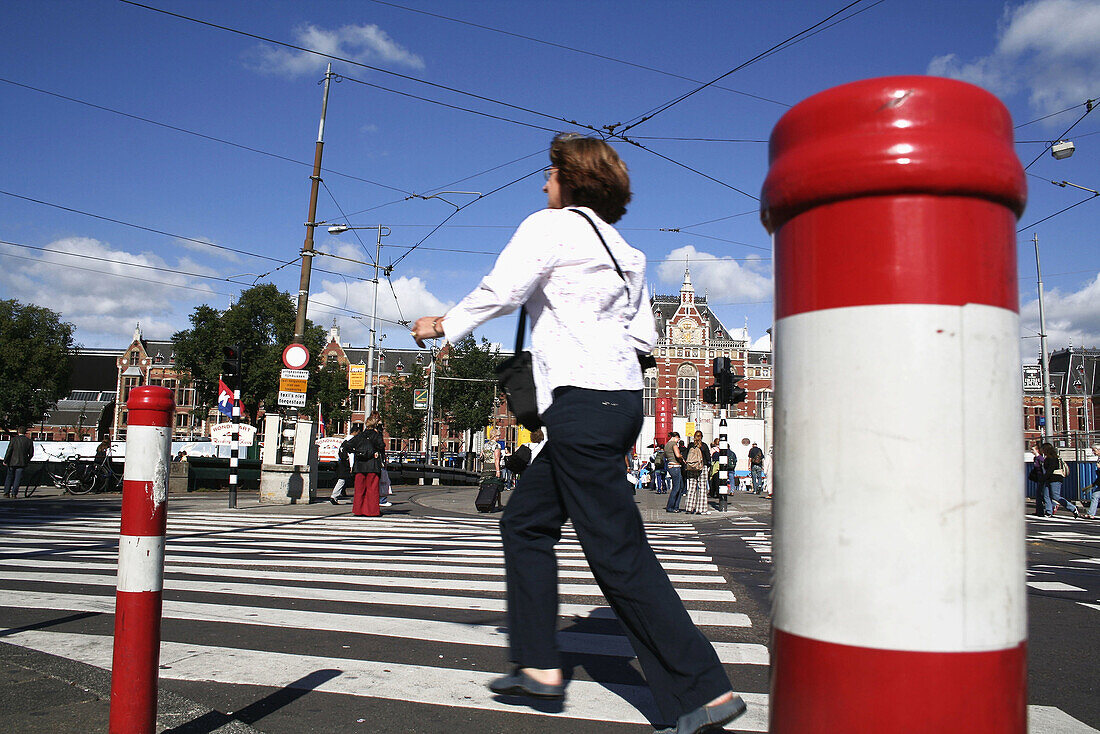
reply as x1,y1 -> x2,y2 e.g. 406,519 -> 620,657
760,76 -> 1027,232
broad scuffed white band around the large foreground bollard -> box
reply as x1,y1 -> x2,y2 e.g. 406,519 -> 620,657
773,304 -> 1027,651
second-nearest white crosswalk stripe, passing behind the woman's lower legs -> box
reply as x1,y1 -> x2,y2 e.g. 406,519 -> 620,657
0,591 -> 768,665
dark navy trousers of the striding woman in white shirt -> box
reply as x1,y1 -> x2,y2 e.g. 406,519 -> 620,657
501,387 -> 730,722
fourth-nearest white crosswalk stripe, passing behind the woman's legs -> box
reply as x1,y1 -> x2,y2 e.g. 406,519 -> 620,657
0,558 -> 737,603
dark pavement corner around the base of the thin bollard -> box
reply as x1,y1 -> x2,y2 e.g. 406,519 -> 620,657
0,640 -> 264,734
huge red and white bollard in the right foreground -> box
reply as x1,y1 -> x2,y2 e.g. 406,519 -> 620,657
761,76 -> 1027,734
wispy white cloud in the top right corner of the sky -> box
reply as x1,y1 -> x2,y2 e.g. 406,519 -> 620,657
927,0 -> 1100,112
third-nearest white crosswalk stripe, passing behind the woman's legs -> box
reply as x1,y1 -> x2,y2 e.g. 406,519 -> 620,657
4,570 -> 752,627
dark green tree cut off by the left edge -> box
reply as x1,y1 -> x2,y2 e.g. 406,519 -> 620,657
0,300 -> 77,428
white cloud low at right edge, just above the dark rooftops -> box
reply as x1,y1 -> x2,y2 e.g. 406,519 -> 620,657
1020,273 -> 1100,349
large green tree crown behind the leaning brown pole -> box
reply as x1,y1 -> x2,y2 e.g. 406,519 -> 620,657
172,283 -> 323,415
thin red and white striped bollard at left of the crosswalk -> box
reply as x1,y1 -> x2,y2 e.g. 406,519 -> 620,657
109,387 -> 175,734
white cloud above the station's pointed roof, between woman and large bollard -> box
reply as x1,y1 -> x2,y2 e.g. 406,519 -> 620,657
655,244 -> 772,306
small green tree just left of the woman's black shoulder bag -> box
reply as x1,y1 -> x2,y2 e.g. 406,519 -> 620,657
436,335 -> 501,431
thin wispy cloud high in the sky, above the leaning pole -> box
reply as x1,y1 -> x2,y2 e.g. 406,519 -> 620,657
246,23 -> 425,77
